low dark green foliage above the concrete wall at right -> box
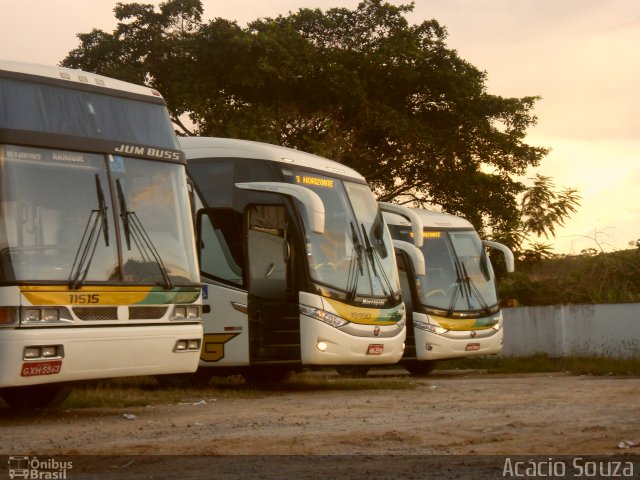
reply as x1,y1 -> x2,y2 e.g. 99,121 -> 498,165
500,249 -> 640,306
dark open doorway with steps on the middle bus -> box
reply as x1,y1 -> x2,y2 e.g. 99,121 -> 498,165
245,205 -> 301,364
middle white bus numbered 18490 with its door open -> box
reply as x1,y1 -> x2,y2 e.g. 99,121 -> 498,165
180,138 -> 405,380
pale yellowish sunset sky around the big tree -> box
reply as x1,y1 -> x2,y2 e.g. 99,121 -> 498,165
0,0 -> 640,254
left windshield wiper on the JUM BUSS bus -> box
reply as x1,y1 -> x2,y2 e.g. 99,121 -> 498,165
69,173 -> 109,290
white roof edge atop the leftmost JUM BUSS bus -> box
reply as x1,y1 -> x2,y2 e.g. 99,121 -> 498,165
0,60 -> 162,98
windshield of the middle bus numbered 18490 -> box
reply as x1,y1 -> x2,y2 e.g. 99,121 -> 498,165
283,170 -> 400,297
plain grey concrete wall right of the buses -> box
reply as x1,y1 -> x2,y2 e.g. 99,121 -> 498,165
502,303 -> 640,357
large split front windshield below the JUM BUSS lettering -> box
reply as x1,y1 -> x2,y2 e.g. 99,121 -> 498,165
0,145 -> 198,287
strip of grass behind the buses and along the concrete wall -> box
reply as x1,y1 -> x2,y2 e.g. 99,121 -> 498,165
55,354 -> 640,409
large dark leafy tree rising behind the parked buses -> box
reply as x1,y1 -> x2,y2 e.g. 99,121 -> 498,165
62,0 -> 575,246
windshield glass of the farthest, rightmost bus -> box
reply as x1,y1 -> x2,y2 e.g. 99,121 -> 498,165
391,226 -> 498,313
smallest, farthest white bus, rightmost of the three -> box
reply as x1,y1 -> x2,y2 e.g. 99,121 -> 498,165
384,209 -> 514,375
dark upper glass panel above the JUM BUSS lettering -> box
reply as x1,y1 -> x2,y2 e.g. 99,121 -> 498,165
0,78 -> 179,149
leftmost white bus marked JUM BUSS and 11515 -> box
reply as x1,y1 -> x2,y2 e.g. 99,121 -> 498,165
0,61 -> 202,407
